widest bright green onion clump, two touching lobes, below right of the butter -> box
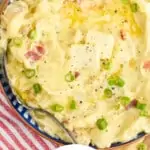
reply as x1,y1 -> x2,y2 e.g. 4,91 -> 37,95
108,76 -> 125,87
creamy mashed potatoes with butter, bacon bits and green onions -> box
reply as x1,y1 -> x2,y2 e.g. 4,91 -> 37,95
1,0 -> 150,148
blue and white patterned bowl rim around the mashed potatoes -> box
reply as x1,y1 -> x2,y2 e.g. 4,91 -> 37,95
0,0 -> 146,148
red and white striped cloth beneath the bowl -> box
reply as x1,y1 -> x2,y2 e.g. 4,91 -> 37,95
0,90 -> 59,150
